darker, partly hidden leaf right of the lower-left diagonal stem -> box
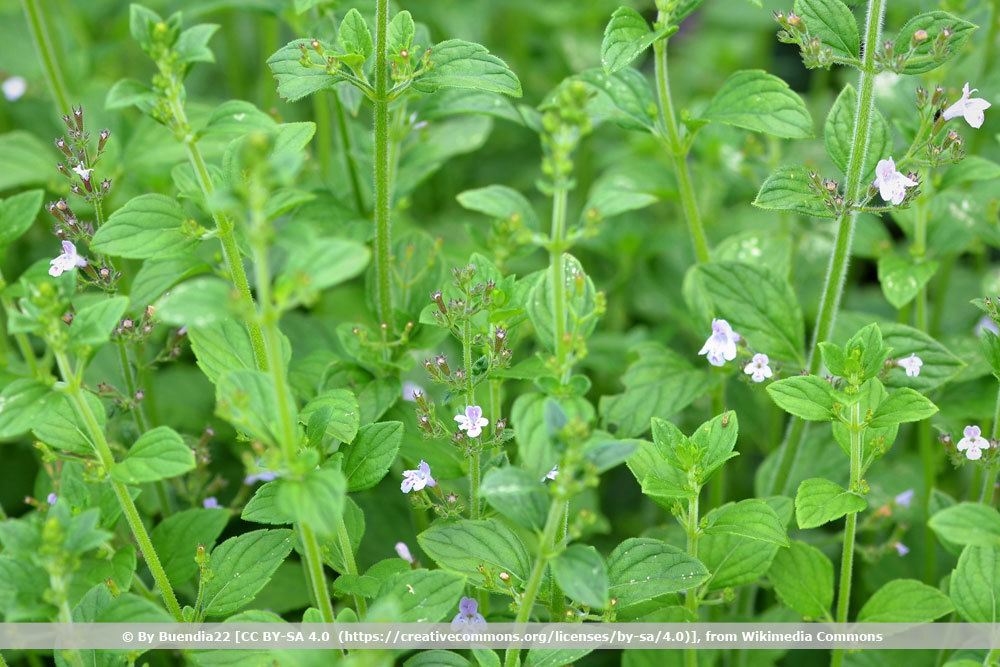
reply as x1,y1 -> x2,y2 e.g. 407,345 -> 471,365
151,509 -> 229,587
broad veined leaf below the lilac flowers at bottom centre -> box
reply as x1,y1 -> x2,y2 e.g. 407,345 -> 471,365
417,519 -> 531,590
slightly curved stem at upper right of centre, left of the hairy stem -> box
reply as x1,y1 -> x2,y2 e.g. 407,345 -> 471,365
653,31 -> 710,264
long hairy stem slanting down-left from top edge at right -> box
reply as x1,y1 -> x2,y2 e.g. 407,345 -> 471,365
770,0 -> 889,495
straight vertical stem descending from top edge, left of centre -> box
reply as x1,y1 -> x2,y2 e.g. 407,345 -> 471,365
374,0 -> 392,326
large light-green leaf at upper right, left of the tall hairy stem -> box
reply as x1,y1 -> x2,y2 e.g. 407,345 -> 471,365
701,70 -> 813,139
